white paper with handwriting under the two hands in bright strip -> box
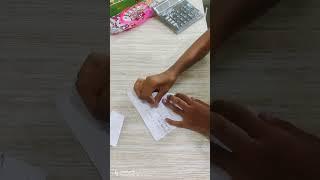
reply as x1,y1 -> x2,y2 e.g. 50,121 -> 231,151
128,88 -> 182,141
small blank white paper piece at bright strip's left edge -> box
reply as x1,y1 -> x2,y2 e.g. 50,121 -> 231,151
110,111 -> 124,146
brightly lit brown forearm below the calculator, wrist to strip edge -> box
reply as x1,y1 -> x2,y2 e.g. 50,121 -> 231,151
168,29 -> 210,76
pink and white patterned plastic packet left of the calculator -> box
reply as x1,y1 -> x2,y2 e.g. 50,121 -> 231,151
110,2 -> 154,34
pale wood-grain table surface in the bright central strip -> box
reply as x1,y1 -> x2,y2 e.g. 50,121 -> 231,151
110,0 -> 210,180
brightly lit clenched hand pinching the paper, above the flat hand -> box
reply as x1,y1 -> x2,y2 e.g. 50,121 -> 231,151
134,71 -> 177,106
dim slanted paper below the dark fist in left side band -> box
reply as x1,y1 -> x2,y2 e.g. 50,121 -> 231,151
56,86 -> 109,180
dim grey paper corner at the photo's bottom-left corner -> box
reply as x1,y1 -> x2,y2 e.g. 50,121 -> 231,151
0,153 -> 47,180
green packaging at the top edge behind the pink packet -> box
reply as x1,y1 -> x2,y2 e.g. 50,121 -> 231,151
110,0 -> 143,17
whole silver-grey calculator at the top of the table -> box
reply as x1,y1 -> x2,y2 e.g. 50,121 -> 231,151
153,0 -> 204,34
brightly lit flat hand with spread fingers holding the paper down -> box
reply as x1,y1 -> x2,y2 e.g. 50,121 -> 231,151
163,93 -> 210,137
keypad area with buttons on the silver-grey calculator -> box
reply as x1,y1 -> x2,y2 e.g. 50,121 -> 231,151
160,0 -> 203,33
